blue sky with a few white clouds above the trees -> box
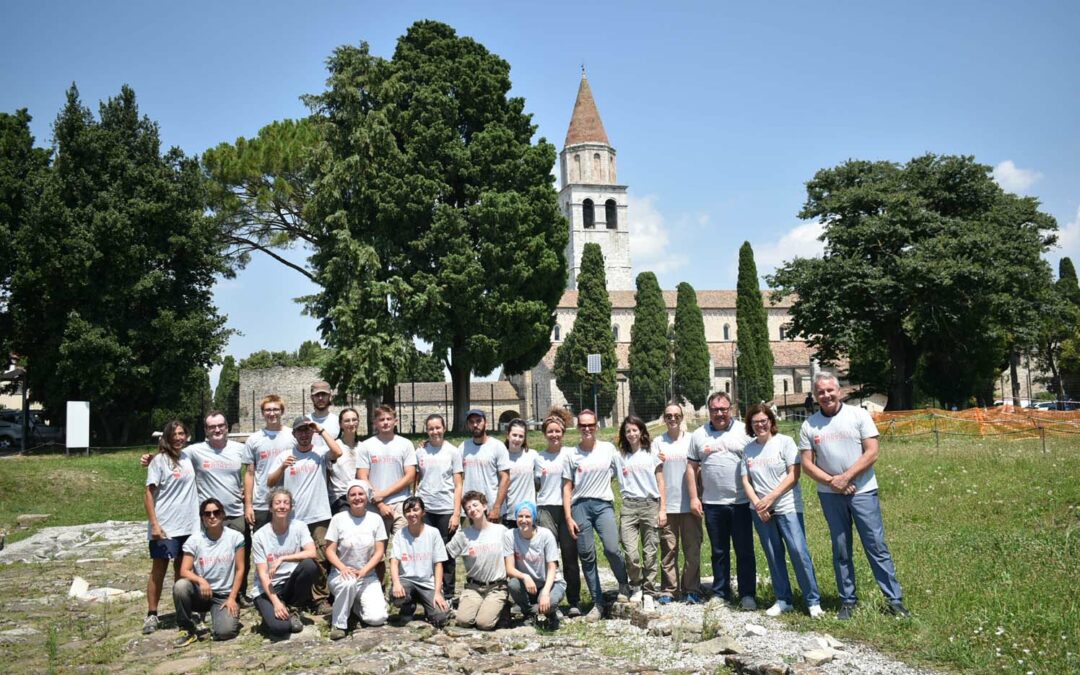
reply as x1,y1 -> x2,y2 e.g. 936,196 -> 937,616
0,0 -> 1080,384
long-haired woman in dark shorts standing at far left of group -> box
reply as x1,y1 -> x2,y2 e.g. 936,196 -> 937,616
143,419 -> 199,633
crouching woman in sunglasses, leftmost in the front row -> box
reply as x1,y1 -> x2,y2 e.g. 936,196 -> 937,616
173,497 -> 247,647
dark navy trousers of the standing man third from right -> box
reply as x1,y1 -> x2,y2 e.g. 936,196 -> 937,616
705,503 -> 757,599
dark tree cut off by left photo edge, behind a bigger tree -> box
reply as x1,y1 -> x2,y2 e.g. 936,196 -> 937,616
0,108 -> 49,362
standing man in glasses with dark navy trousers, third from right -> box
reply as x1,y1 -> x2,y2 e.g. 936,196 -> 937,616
687,392 -> 757,610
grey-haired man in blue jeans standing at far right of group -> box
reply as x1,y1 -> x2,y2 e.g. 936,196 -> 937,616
799,370 -> 912,620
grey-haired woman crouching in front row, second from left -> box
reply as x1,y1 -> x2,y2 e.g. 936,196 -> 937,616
252,487 -> 319,637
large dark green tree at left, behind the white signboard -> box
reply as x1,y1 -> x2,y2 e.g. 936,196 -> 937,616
10,85 -> 228,444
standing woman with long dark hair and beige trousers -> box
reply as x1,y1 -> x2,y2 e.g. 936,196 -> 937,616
615,415 -> 667,603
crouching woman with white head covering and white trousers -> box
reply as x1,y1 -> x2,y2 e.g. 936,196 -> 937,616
326,481 -> 388,639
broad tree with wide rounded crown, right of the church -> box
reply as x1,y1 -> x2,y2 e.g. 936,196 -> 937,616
770,154 -> 1056,409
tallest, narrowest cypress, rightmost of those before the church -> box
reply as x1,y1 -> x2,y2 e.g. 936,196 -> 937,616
735,242 -> 772,410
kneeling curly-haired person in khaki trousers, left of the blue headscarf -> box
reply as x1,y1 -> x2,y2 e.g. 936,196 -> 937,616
446,490 -> 507,631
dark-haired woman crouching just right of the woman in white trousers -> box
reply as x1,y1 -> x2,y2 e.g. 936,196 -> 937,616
390,497 -> 450,629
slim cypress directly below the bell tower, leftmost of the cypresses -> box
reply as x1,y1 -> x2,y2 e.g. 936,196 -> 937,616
554,244 -> 619,417
